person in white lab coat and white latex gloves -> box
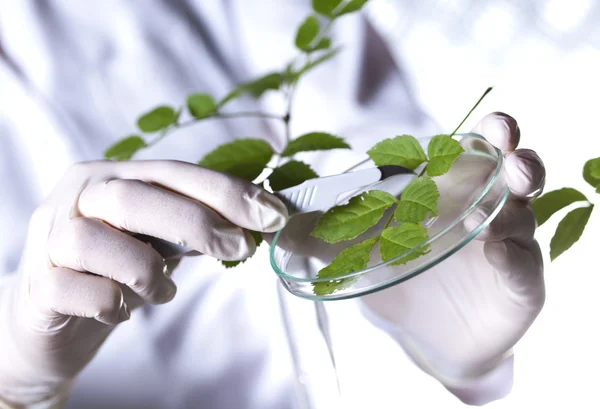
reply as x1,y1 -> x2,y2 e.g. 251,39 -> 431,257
0,0 -> 545,409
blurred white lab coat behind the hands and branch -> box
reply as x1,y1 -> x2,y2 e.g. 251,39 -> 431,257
0,0 -> 482,409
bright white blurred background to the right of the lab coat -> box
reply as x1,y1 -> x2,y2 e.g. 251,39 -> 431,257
360,0 -> 600,409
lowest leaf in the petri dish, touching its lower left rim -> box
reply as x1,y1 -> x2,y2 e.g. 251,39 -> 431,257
313,237 -> 379,295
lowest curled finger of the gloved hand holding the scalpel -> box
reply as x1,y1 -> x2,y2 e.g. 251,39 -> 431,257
30,267 -> 131,325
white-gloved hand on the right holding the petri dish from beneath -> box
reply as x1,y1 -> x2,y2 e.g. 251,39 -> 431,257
361,113 -> 545,404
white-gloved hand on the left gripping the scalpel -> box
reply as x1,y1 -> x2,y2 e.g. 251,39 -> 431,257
0,161 -> 287,408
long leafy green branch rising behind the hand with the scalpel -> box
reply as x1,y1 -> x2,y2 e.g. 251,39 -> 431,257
104,0 -> 368,268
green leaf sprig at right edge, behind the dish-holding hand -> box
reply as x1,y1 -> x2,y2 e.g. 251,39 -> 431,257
532,158 -> 600,261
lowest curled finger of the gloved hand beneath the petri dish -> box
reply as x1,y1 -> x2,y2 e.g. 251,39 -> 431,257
483,239 -> 545,310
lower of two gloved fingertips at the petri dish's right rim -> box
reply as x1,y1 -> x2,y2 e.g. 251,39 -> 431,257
504,149 -> 546,199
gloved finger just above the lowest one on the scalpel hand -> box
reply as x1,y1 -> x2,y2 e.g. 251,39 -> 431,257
48,217 -> 177,304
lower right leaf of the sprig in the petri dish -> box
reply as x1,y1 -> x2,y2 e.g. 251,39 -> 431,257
379,223 -> 429,265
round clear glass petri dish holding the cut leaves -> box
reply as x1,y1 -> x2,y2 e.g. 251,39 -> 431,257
270,133 -> 509,301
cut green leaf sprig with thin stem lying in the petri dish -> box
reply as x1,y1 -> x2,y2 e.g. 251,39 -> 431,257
311,87 -> 492,296
